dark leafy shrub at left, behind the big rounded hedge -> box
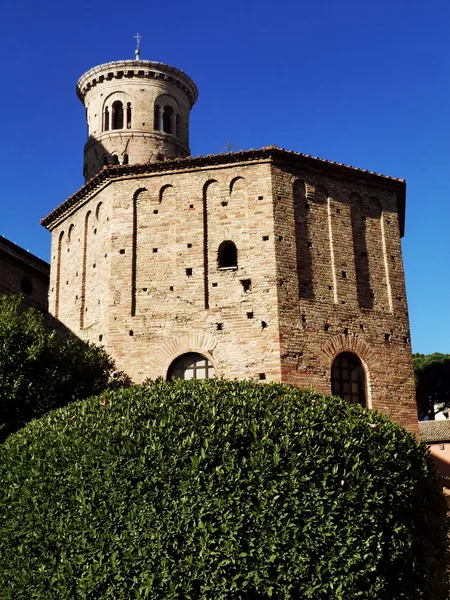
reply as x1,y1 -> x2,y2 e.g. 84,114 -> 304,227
0,295 -> 118,441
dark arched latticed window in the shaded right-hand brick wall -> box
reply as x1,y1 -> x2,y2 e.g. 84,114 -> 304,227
331,352 -> 366,406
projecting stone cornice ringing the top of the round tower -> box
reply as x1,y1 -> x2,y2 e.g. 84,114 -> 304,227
77,60 -> 198,108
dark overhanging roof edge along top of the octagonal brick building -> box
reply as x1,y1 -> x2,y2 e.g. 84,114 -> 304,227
41,146 -> 406,236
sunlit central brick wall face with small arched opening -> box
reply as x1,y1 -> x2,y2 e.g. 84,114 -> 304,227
109,164 -> 280,381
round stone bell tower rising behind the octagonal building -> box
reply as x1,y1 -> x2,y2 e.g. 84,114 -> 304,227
77,60 -> 198,181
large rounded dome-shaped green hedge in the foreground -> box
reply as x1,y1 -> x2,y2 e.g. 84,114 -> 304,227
0,380 -> 447,600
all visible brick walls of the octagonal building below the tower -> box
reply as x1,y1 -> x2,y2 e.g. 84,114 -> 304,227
43,61 -> 417,431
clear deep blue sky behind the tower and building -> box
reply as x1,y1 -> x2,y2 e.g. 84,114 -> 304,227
0,0 -> 450,353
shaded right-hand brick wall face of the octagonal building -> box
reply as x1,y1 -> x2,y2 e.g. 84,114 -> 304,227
273,166 -> 417,432
